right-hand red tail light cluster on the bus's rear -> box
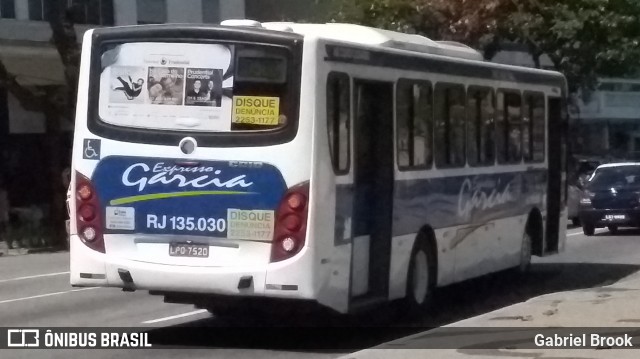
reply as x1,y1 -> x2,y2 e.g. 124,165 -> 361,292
271,182 -> 309,263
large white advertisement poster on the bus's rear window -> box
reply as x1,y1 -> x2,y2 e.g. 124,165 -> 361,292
99,42 -> 234,132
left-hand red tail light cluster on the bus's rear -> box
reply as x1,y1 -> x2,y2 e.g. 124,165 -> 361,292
75,172 -> 105,253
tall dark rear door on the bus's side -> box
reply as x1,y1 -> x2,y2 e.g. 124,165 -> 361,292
350,80 -> 393,306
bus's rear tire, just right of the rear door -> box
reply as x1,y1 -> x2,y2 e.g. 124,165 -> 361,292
402,235 -> 435,315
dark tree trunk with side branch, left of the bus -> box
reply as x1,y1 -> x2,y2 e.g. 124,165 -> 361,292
0,0 -> 80,246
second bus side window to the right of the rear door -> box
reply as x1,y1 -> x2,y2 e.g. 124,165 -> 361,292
434,83 -> 466,167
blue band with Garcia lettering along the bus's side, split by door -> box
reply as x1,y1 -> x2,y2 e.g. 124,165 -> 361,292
334,169 -> 548,245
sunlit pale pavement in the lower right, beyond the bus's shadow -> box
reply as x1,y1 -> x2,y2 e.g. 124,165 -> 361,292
343,272 -> 640,359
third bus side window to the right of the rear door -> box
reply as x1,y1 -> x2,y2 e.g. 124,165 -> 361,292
467,86 -> 496,166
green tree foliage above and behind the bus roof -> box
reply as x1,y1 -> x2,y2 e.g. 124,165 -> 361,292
335,0 -> 640,91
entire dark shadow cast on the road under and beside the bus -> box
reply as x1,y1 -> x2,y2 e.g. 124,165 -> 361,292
144,263 -> 640,354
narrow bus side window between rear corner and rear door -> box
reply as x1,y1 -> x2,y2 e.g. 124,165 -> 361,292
327,72 -> 351,174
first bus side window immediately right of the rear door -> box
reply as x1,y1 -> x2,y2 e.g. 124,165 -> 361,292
396,80 -> 433,169
